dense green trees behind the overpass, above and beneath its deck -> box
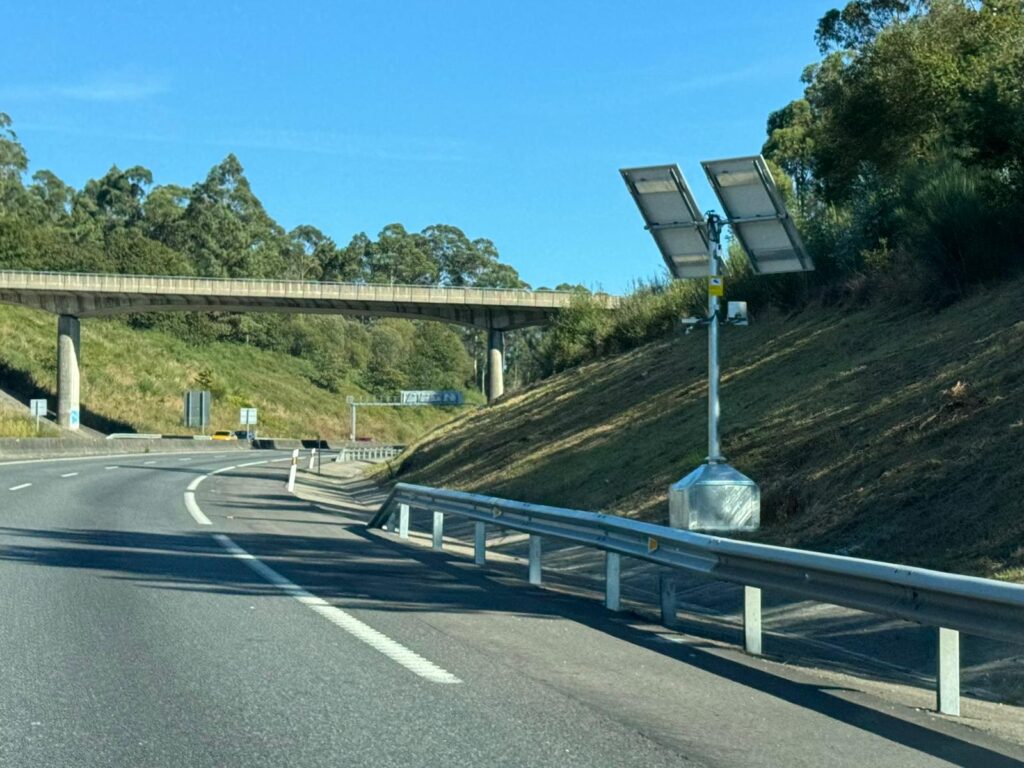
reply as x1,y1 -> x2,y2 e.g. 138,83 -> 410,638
0,118 -> 525,403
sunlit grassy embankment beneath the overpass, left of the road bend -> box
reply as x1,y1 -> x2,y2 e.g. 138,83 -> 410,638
0,305 -> 471,442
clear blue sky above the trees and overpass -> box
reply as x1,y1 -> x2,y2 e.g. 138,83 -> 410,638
0,0 -> 836,291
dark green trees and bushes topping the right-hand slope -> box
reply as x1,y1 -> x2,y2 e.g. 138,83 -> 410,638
537,0 -> 1024,373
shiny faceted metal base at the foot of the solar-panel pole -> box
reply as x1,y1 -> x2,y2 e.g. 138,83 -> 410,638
669,464 -> 761,532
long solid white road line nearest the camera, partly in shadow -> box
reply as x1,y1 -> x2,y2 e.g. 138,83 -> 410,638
213,534 -> 462,685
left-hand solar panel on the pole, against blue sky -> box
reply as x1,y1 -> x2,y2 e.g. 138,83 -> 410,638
620,165 -> 711,278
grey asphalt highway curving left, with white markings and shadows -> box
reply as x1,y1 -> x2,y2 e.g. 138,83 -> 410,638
0,453 -> 1024,768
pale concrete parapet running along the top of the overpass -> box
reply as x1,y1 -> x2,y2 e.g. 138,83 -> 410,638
0,269 -> 617,309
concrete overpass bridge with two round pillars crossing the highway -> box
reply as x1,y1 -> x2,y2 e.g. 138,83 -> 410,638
0,270 -> 618,429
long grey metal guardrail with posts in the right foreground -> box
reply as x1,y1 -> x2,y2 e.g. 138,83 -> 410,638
369,483 -> 1024,715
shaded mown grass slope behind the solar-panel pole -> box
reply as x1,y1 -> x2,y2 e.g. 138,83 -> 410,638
397,281 -> 1024,580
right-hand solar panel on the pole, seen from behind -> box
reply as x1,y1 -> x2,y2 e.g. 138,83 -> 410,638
701,156 -> 814,274
